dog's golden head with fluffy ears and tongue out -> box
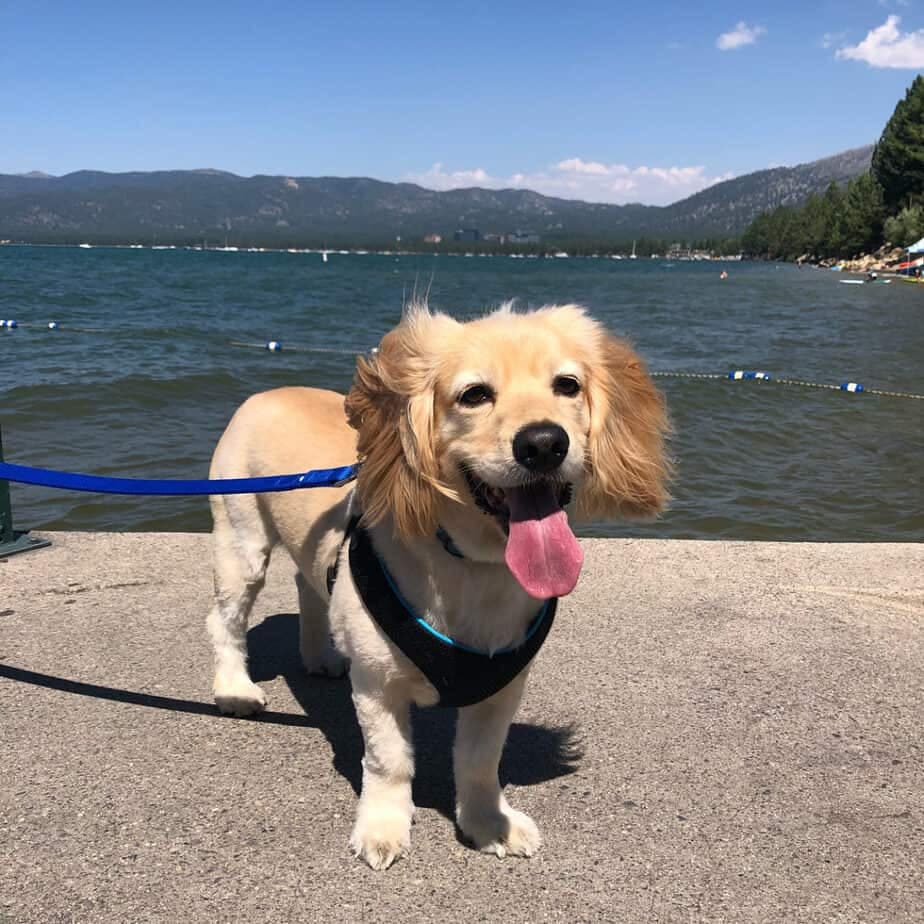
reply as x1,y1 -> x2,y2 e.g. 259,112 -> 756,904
346,305 -> 668,598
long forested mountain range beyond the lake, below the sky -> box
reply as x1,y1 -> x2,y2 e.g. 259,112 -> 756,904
0,147 -> 872,246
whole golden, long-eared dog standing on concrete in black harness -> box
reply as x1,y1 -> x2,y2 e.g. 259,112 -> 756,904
208,304 -> 669,869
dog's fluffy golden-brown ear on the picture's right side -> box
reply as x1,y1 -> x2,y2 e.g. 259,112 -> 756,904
577,330 -> 670,520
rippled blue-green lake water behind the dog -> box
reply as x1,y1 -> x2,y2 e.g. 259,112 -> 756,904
0,247 -> 924,541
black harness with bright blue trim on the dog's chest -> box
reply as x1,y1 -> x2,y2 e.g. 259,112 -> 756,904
327,517 -> 558,706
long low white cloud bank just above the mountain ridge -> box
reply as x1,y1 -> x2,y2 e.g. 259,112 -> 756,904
404,157 -> 731,205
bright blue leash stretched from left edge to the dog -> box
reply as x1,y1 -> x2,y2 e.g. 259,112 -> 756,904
0,462 -> 359,497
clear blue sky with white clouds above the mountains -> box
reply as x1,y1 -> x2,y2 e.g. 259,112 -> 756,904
0,0 -> 924,204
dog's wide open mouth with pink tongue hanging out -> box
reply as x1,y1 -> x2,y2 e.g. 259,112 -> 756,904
464,469 -> 584,600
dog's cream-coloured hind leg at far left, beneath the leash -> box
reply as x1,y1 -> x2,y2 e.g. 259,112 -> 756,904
208,495 -> 274,715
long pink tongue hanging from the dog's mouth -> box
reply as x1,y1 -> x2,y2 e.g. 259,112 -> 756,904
504,487 -> 584,600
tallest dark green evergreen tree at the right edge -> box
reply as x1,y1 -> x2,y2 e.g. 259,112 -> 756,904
873,74 -> 924,213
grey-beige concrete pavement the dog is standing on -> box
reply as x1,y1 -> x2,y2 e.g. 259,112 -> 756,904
0,533 -> 924,924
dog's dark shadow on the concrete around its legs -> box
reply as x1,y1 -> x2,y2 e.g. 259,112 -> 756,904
247,613 -> 582,819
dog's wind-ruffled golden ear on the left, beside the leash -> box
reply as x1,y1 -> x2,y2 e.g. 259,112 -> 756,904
345,307 -> 457,538
